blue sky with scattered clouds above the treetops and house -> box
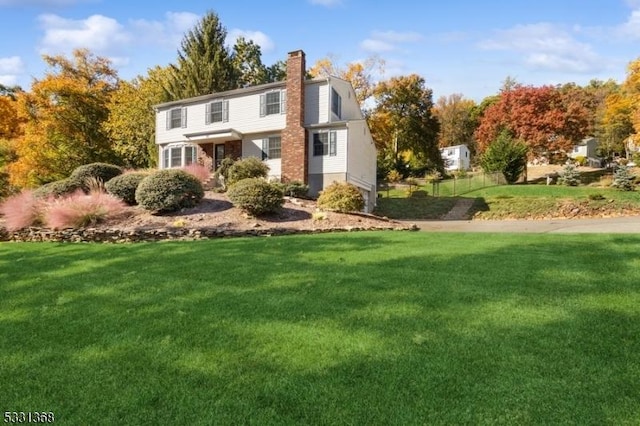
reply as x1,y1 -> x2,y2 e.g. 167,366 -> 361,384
0,0 -> 640,101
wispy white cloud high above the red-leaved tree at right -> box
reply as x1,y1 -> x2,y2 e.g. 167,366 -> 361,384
478,23 -> 603,73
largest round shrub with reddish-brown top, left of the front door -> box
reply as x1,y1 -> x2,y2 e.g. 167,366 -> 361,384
135,169 -> 204,212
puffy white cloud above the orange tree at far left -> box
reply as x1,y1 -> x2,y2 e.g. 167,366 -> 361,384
38,14 -> 130,54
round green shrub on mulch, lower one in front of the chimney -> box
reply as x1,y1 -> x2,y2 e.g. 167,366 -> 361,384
227,178 -> 284,216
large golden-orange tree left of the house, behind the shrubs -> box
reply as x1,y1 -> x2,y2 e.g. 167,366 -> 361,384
7,49 -> 118,187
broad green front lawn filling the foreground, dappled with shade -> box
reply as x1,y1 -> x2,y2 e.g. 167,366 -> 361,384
0,231 -> 640,425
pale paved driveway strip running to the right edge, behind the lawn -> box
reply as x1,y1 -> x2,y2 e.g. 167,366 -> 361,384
403,216 -> 640,234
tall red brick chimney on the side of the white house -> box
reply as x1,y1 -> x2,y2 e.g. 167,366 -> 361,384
281,50 -> 309,183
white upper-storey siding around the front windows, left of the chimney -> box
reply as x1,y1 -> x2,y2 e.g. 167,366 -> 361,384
156,91 -> 286,144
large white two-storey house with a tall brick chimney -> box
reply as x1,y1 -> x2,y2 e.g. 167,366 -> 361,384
155,50 -> 376,211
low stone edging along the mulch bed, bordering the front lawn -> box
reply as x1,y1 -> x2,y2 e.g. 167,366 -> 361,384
0,224 -> 418,243
